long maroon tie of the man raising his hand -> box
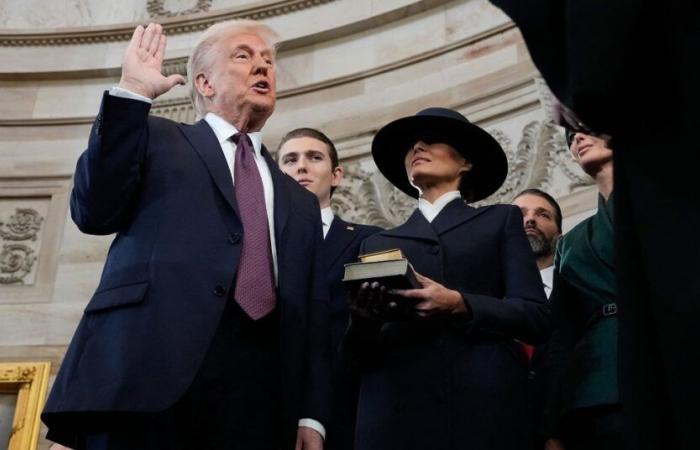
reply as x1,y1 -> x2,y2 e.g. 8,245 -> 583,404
231,133 -> 277,320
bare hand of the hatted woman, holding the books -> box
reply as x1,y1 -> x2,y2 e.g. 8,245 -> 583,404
392,272 -> 469,317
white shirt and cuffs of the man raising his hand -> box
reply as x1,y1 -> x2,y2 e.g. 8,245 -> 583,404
109,86 -> 332,439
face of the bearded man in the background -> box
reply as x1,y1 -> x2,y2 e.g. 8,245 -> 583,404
513,194 -> 561,257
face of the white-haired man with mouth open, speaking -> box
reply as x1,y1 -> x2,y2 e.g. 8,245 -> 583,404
196,33 -> 276,131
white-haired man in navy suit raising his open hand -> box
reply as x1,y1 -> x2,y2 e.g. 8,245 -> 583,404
43,21 -> 330,450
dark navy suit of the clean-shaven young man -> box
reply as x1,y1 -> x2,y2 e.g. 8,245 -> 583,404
323,216 -> 381,450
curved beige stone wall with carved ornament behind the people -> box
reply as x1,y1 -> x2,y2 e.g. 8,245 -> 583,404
0,0 -> 595,442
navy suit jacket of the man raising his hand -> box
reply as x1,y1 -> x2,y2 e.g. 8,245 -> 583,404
43,93 -> 330,446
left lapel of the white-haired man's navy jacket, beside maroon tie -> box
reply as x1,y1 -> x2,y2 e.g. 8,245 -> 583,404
180,120 -> 238,214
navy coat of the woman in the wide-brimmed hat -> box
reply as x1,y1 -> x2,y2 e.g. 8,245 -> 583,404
344,199 -> 550,450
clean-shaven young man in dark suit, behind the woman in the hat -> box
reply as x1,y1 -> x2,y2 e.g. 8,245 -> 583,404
277,128 -> 380,450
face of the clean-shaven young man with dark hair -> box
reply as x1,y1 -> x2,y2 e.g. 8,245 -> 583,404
277,137 -> 343,208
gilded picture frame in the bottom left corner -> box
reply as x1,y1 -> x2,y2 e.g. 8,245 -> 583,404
0,361 -> 51,450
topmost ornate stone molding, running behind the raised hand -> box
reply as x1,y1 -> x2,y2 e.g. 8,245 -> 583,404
0,0 -> 335,47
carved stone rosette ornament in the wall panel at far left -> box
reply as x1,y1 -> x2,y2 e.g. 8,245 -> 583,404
0,208 -> 44,285
